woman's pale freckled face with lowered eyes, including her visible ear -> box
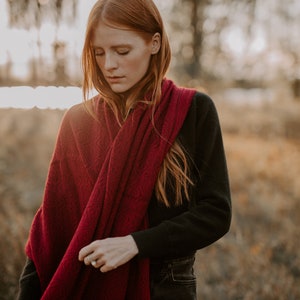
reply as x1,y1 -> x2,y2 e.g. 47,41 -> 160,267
92,22 -> 156,93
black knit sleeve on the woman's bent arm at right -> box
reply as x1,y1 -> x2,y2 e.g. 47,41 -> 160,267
132,93 -> 231,258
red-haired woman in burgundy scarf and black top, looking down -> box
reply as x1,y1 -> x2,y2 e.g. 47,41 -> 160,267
19,0 -> 231,300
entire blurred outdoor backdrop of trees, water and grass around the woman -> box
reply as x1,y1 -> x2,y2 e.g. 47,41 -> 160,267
0,0 -> 300,300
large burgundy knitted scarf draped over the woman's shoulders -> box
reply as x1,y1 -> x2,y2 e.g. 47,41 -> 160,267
26,80 -> 195,300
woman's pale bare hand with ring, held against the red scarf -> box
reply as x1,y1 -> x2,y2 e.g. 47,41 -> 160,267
78,235 -> 139,272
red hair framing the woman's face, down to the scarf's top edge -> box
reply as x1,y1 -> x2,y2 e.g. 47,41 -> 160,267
82,0 -> 171,116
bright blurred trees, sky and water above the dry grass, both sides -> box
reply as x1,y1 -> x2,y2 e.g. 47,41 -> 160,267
0,0 -> 300,108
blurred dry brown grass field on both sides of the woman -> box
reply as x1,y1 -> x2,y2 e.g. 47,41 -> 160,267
0,97 -> 300,300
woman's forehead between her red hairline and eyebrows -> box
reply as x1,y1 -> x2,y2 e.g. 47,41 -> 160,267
91,22 -> 145,47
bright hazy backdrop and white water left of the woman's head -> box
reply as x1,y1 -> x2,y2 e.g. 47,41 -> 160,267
0,0 -> 94,108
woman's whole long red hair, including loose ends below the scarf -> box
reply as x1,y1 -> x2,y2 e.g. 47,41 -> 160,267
82,0 -> 192,206
